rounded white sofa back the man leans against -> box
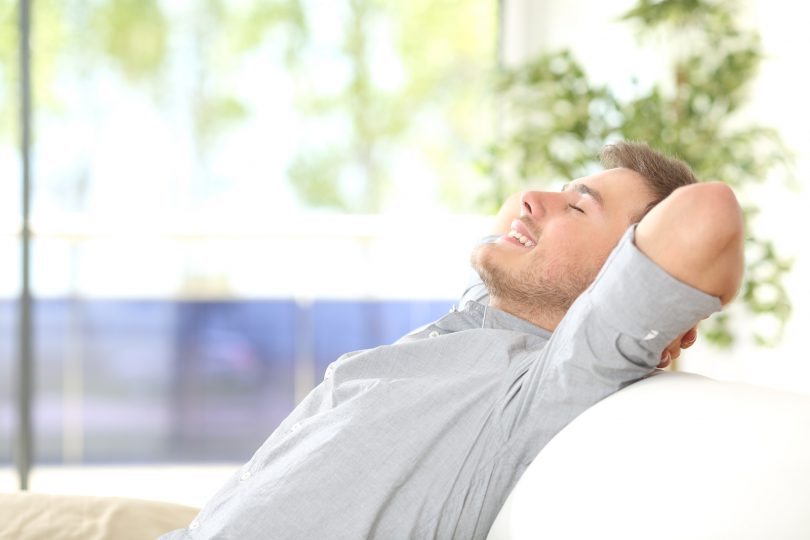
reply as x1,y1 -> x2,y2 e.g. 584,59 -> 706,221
488,372 -> 810,540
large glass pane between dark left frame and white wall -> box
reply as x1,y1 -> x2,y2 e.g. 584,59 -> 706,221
33,0 -> 496,463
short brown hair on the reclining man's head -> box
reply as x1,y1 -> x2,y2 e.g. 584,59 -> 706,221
599,141 -> 698,223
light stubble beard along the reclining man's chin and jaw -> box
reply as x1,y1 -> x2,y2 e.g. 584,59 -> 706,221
470,244 -> 596,329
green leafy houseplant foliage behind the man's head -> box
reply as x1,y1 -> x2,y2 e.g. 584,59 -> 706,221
488,0 -> 791,346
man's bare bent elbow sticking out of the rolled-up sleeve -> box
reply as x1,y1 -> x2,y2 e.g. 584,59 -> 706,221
635,182 -> 744,305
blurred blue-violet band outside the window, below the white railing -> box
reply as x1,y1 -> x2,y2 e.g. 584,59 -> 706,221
0,300 -> 452,463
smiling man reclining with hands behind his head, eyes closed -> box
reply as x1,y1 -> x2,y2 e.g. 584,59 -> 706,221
159,142 -> 743,540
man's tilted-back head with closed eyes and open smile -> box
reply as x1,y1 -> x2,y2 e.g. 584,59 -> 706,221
472,142 -> 697,330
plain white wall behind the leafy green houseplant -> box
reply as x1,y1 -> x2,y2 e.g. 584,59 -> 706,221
504,0 -> 810,393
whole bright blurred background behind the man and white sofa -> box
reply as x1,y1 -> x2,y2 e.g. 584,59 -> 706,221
0,0 -> 810,505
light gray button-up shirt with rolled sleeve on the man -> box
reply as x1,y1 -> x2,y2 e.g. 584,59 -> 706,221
163,227 -> 720,540
